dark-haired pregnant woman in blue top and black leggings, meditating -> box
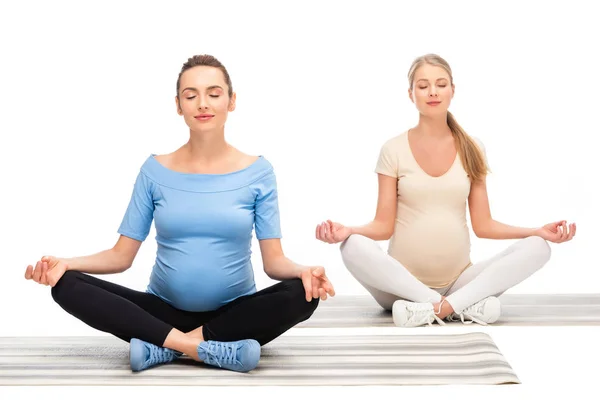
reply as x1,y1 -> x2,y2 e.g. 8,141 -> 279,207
25,55 -> 335,372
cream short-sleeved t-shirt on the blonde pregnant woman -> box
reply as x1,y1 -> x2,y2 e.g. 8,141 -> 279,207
375,132 -> 487,288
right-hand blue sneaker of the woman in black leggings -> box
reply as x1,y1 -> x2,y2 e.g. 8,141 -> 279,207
198,339 -> 260,372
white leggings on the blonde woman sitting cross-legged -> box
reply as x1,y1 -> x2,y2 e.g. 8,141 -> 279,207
340,235 -> 550,313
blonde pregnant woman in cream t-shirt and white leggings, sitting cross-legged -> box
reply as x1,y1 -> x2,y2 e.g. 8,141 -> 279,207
316,54 -> 576,327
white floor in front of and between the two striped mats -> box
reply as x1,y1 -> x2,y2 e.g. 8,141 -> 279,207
0,325 -> 600,400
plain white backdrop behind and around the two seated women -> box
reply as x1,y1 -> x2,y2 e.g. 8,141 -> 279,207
0,1 -> 600,396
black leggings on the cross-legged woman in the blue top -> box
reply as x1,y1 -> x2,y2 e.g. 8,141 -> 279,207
52,271 -> 319,346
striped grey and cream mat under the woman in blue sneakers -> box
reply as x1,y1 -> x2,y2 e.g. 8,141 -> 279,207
0,333 -> 520,386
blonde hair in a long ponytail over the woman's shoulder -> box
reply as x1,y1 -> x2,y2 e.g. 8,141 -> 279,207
408,54 -> 488,181
